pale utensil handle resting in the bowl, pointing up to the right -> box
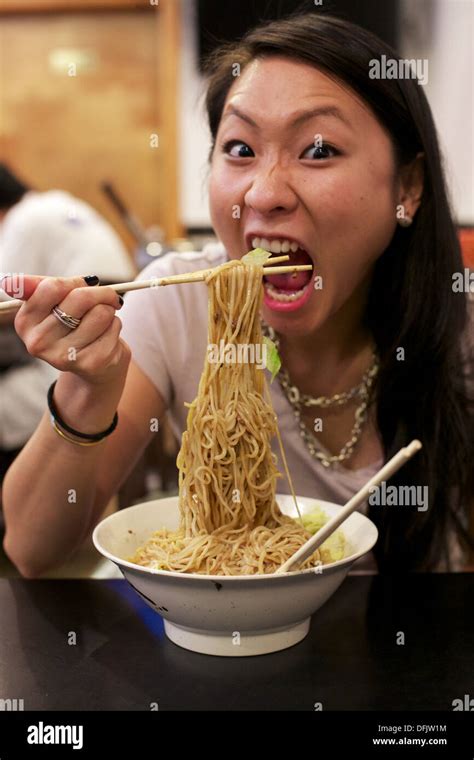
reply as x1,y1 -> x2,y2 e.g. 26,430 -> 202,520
275,438 -> 422,574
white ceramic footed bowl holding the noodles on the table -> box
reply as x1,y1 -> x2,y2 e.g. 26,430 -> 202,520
93,495 -> 377,657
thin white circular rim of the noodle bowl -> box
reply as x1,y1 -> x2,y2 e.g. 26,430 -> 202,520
92,494 -> 379,583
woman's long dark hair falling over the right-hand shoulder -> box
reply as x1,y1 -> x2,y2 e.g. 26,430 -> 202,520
206,13 -> 474,572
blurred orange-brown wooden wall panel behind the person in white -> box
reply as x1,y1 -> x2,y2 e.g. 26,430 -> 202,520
0,0 -> 180,252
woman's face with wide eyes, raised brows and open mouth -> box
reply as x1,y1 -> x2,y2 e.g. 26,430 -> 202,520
210,57 -> 398,336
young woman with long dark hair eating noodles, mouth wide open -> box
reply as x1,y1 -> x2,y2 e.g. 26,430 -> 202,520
4,15 -> 474,576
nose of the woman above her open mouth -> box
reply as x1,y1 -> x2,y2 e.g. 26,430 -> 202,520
245,162 -> 298,215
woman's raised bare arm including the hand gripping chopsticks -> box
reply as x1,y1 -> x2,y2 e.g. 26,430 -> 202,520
2,276 -> 168,577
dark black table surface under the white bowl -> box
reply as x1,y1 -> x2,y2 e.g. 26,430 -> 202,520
0,574 -> 474,710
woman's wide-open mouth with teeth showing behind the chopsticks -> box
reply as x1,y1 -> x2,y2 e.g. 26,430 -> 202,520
250,237 -> 314,311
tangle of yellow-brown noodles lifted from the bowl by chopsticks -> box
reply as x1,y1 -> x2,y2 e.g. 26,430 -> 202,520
131,261 -> 344,575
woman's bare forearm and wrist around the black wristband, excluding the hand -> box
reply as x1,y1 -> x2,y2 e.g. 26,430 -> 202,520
3,363 -> 165,578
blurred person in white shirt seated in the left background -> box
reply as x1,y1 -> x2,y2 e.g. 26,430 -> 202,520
0,163 -> 136,506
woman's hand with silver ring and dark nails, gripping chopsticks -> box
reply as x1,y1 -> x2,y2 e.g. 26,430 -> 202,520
2,275 -> 130,385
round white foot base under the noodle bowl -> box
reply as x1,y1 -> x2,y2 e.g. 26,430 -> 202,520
164,618 -> 310,657
